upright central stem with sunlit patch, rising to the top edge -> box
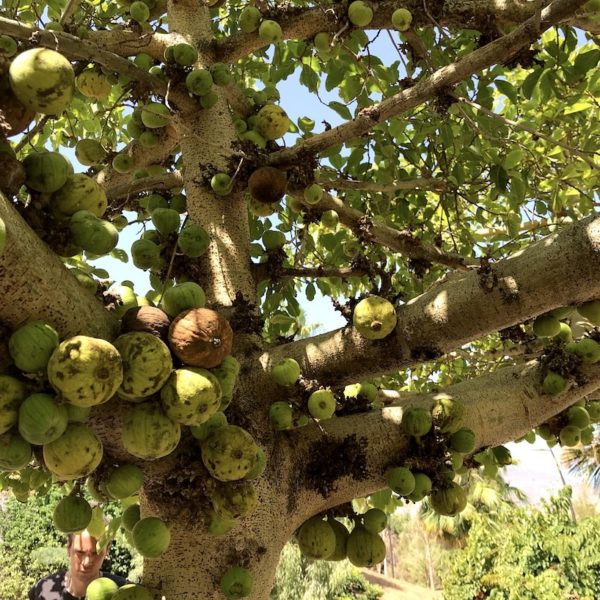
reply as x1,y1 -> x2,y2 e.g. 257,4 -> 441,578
168,2 -> 256,306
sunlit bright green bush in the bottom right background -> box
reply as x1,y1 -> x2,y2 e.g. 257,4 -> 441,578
442,488 -> 600,600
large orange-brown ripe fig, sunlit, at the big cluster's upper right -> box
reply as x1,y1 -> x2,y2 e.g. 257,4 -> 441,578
169,308 -> 233,369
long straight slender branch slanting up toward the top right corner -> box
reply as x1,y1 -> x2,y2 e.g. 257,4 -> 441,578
268,0 -> 585,165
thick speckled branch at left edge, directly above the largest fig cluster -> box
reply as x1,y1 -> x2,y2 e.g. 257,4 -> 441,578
0,195 -> 117,339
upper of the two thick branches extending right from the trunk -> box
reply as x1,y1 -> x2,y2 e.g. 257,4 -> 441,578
261,217 -> 600,385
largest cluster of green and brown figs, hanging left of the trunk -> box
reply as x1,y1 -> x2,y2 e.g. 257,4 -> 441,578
0,292 -> 266,598
